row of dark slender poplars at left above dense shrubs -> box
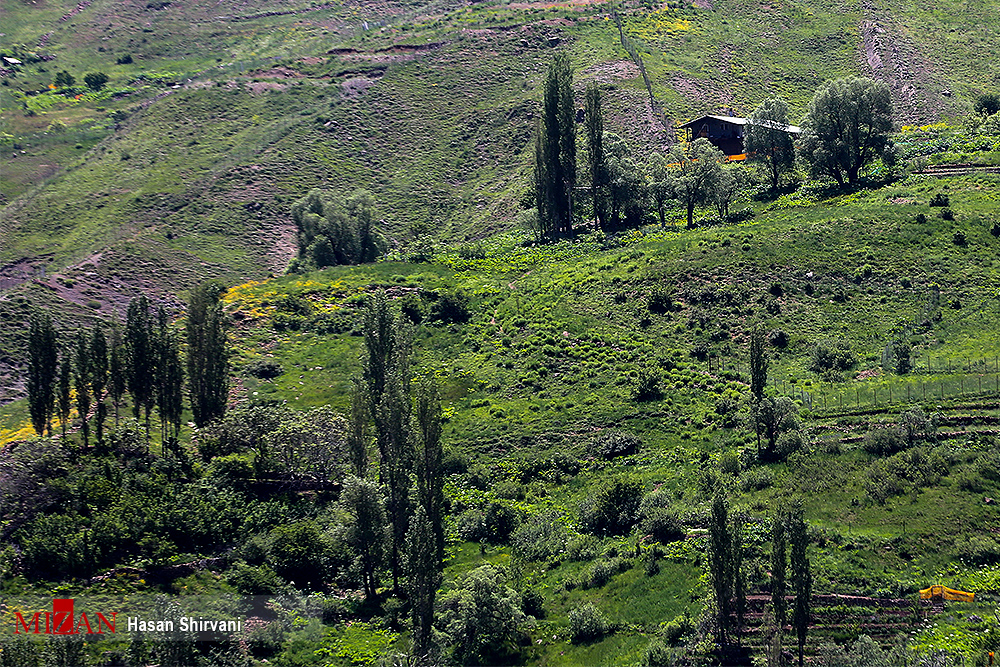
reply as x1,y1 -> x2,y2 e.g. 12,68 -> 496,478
27,283 -> 229,447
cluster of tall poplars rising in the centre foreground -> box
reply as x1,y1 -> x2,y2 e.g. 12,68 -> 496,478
343,291 -> 444,658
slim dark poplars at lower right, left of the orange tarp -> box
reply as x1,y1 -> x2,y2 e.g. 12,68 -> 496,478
708,493 -> 812,666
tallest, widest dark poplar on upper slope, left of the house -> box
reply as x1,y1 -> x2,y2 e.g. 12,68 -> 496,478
535,54 -> 576,238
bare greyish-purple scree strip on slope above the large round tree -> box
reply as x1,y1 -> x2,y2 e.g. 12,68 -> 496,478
860,0 -> 952,125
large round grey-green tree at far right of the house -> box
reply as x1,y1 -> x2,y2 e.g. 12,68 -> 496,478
800,77 -> 892,185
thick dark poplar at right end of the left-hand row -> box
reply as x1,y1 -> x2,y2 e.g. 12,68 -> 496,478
187,282 -> 229,426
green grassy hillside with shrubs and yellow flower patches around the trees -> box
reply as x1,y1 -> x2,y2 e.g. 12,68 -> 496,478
0,0 -> 1000,667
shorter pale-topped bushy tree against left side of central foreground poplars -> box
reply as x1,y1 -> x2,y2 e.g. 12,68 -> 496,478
341,476 -> 387,602
